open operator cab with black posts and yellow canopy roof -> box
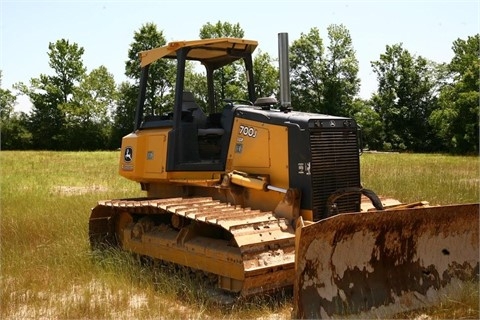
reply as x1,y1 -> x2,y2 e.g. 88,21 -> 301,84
135,38 -> 263,171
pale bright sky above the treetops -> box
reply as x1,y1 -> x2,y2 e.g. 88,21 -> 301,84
0,0 -> 480,111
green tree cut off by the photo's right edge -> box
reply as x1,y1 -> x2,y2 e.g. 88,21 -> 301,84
429,34 -> 480,154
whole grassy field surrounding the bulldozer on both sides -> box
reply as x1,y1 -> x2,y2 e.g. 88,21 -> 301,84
0,151 -> 480,319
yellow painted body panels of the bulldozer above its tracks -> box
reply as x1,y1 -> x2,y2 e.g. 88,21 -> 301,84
119,118 -> 294,214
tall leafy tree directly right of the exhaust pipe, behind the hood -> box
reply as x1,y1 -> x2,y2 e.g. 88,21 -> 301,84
290,25 -> 360,116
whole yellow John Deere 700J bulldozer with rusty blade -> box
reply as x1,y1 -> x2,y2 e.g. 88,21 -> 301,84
89,33 -> 479,318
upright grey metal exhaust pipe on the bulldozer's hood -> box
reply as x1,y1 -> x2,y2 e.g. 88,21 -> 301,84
278,32 -> 292,110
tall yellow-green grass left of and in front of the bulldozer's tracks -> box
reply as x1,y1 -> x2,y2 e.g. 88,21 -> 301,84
0,151 -> 290,319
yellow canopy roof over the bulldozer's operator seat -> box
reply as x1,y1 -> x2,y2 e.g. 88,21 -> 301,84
138,38 -> 258,67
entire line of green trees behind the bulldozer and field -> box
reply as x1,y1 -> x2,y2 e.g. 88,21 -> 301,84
0,21 -> 480,154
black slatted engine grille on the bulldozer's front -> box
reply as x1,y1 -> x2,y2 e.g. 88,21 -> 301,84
310,129 -> 360,221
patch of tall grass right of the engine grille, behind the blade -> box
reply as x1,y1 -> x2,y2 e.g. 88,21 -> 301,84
360,153 -> 480,205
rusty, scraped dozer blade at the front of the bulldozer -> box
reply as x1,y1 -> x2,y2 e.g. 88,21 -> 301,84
292,204 -> 479,319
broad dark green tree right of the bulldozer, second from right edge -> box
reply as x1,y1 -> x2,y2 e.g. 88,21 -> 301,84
372,44 -> 438,151
